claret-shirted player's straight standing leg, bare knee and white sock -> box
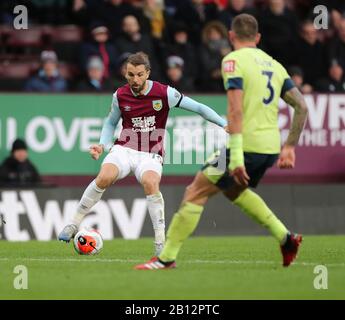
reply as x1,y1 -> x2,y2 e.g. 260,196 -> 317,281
141,170 -> 165,256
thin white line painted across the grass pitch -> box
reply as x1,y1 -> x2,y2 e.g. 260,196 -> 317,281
0,257 -> 345,267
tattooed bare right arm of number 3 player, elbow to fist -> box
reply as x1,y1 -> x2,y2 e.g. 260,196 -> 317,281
278,87 -> 308,169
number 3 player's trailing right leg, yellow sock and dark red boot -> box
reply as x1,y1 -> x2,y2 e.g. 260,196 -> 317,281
223,184 -> 302,267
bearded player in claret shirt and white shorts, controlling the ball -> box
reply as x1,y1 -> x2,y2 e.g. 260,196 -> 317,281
58,52 -> 227,256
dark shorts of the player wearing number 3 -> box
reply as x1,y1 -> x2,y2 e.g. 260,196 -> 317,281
201,148 -> 278,190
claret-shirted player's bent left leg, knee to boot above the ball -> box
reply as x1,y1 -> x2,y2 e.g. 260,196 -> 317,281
58,163 -> 119,242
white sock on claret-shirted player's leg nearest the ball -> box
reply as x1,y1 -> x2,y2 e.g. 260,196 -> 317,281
72,180 -> 105,227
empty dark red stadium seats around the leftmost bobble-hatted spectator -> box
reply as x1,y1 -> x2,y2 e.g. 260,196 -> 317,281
0,25 -> 84,91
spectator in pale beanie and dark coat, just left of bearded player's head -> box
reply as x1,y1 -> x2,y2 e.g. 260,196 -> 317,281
77,56 -> 114,92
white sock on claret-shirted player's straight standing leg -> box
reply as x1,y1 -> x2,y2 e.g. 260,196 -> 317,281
146,192 -> 165,248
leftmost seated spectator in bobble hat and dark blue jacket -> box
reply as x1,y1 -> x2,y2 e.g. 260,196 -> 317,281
24,51 -> 67,92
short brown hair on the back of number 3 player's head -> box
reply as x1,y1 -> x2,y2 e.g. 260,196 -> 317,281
231,13 -> 259,41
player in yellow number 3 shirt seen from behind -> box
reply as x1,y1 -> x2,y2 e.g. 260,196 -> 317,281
135,14 -> 307,270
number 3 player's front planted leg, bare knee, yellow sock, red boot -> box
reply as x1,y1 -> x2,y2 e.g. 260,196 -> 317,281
135,172 -> 219,270
